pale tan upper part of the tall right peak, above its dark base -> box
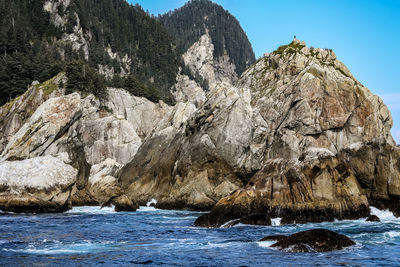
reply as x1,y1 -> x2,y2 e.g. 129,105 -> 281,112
236,39 -> 395,158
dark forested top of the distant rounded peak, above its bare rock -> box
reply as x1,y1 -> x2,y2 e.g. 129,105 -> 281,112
159,0 -> 255,76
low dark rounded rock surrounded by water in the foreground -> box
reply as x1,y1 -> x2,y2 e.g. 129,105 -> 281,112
272,229 -> 355,252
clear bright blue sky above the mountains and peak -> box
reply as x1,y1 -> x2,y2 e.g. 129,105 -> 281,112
129,0 -> 400,143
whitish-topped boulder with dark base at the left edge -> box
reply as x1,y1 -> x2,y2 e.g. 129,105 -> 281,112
0,156 -> 78,213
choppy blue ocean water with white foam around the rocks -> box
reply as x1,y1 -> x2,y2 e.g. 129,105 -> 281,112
0,207 -> 400,266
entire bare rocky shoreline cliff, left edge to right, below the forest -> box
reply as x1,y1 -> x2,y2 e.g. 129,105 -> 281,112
0,37 -> 400,220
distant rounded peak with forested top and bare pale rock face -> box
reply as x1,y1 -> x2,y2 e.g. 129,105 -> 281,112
162,0 -> 255,107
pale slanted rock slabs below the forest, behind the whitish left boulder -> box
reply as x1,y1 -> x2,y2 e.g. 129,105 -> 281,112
0,74 -> 177,212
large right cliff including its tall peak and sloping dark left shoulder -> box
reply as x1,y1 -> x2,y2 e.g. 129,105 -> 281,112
120,40 -> 399,222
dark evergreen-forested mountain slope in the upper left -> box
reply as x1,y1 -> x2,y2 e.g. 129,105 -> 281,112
0,0 -> 179,104
